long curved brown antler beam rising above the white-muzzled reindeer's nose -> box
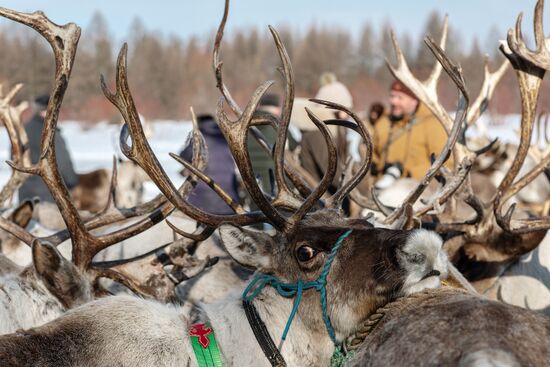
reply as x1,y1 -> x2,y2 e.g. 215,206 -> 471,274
384,37 -> 469,224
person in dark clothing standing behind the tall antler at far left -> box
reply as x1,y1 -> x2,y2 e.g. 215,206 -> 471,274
19,95 -> 78,203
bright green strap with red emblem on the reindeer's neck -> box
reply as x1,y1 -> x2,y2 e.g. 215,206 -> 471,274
189,324 -> 223,367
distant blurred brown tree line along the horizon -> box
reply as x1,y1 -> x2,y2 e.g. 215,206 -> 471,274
0,12 -> 550,123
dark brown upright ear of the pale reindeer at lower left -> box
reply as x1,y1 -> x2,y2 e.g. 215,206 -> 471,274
32,240 -> 92,308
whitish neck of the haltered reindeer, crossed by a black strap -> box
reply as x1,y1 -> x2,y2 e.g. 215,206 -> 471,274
203,288 -> 334,366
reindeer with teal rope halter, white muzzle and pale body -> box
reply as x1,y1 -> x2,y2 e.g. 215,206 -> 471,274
0,2 -> 550,366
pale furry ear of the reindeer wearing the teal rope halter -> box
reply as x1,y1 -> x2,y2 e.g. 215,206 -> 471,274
220,224 -> 276,270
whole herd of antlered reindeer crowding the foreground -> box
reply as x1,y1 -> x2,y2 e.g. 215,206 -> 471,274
0,0 -> 550,366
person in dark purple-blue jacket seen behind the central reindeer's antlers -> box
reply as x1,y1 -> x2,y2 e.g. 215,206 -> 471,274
180,114 -> 239,214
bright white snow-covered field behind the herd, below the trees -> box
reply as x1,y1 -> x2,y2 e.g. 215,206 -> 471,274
0,115 -> 532,204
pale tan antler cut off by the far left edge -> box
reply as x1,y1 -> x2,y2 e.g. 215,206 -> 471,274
0,84 -> 31,204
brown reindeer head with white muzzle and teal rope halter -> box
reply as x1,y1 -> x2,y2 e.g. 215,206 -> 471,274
220,210 -> 447,342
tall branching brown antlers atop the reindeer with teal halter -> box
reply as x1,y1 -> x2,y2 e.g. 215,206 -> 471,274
108,2 -> 337,234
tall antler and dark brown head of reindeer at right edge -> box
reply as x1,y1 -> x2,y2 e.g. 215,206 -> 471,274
436,0 -> 550,261
